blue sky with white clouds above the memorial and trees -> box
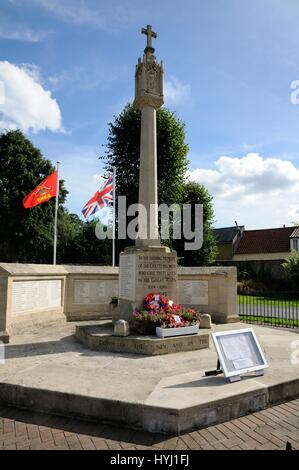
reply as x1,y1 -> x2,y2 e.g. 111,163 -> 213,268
0,0 -> 299,228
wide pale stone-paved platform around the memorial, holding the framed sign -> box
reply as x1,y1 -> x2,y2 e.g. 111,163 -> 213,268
0,323 -> 299,434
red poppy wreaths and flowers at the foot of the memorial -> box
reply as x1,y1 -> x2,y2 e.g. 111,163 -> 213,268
131,293 -> 200,335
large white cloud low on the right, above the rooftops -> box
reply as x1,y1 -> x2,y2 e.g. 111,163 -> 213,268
189,153 -> 299,228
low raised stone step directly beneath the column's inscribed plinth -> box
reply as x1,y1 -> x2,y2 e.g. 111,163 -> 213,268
76,322 -> 210,356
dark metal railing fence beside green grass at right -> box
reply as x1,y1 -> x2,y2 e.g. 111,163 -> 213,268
238,292 -> 299,328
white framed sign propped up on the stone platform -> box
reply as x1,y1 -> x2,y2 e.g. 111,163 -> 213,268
212,328 -> 268,382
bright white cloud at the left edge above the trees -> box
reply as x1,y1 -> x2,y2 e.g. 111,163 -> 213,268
0,61 -> 63,132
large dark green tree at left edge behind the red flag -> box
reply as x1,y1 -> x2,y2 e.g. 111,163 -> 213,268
0,131 -> 67,263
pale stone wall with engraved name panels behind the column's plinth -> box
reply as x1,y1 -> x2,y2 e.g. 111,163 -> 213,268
0,262 -> 238,341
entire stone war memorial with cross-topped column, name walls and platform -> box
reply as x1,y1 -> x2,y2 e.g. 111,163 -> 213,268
0,26 -> 299,434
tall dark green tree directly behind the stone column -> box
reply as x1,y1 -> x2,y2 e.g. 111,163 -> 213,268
106,104 -> 188,210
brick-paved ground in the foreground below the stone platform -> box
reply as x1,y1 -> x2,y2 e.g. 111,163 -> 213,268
0,400 -> 299,450
